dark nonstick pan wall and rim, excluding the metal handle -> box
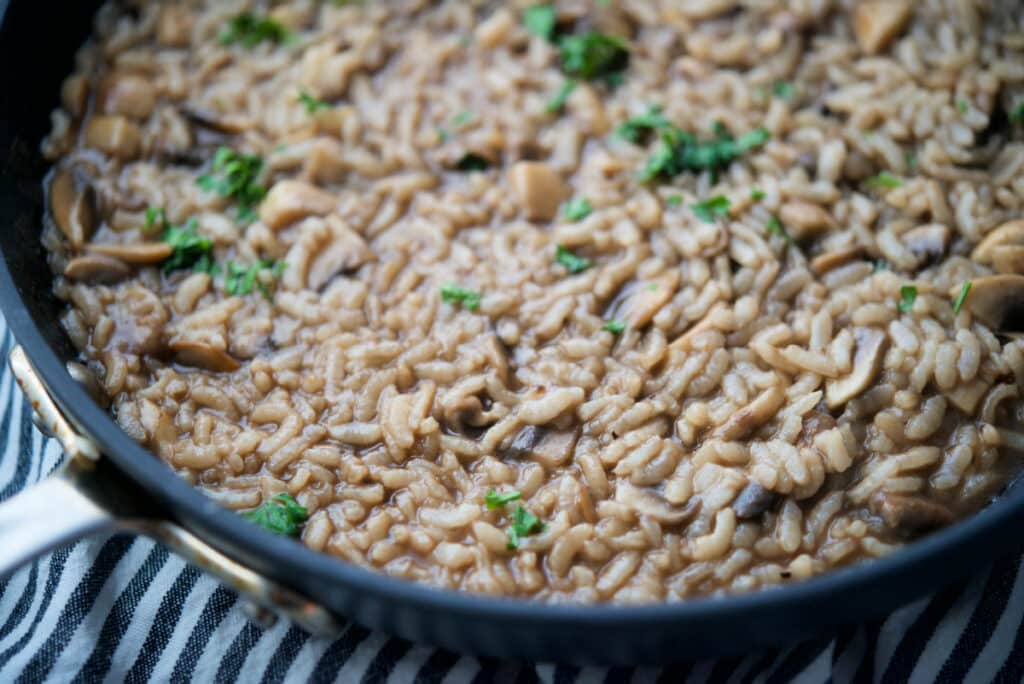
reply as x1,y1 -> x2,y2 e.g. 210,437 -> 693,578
0,0 -> 1024,665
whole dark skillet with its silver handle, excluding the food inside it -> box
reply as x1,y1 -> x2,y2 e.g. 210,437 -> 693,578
0,0 -> 1024,665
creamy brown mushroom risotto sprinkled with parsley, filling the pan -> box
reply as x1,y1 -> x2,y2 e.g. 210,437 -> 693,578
43,0 -> 1024,603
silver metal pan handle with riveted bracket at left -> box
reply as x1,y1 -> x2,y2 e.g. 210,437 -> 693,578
0,346 -> 340,636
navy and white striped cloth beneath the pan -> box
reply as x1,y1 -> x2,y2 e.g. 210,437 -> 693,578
0,322 -> 1024,684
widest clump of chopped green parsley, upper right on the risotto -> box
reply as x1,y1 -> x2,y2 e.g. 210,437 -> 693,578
640,125 -> 771,182
